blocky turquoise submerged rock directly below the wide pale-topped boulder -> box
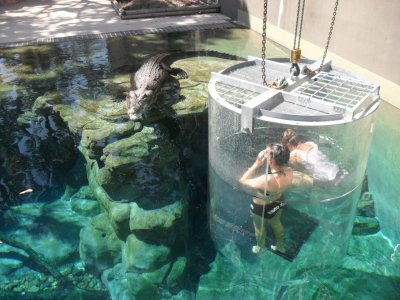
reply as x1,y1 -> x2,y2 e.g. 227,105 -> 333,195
122,234 -> 171,272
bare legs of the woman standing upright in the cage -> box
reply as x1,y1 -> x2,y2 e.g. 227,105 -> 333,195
251,209 -> 285,249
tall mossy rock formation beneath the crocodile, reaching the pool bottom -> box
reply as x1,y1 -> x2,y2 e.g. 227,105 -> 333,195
10,55 -> 238,299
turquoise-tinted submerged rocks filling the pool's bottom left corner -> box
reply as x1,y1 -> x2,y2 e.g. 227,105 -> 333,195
0,186 -> 107,299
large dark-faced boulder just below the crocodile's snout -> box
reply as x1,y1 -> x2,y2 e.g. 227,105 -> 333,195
79,121 -> 179,206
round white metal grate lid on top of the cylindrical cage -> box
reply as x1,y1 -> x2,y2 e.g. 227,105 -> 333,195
209,58 -> 380,131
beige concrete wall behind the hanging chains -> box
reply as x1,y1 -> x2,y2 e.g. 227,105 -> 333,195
220,0 -> 400,108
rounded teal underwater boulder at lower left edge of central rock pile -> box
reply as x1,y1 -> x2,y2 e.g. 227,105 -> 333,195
79,213 -> 121,274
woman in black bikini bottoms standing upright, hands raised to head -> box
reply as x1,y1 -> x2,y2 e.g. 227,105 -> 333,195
239,143 -> 293,253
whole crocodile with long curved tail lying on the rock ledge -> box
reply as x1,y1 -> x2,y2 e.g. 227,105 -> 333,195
126,50 -> 245,120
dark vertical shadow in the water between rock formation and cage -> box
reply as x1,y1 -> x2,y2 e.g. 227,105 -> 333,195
172,112 -> 216,289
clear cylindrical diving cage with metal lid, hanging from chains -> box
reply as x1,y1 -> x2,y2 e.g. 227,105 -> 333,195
208,57 -> 380,270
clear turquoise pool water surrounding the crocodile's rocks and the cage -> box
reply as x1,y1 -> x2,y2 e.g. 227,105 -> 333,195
0,29 -> 400,299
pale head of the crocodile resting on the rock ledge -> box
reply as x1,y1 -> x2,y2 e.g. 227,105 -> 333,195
127,89 -> 154,120
